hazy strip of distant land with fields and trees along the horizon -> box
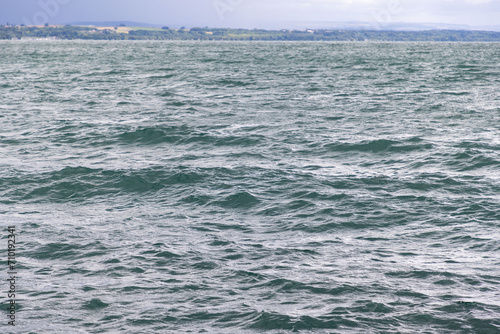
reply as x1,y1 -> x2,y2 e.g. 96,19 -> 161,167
0,22 -> 500,42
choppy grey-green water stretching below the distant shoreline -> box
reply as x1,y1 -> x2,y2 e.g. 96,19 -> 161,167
0,41 -> 500,333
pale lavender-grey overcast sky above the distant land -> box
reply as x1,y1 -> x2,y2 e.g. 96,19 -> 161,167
0,0 -> 500,29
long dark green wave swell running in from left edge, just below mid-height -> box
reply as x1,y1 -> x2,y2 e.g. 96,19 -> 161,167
0,167 -> 207,202
